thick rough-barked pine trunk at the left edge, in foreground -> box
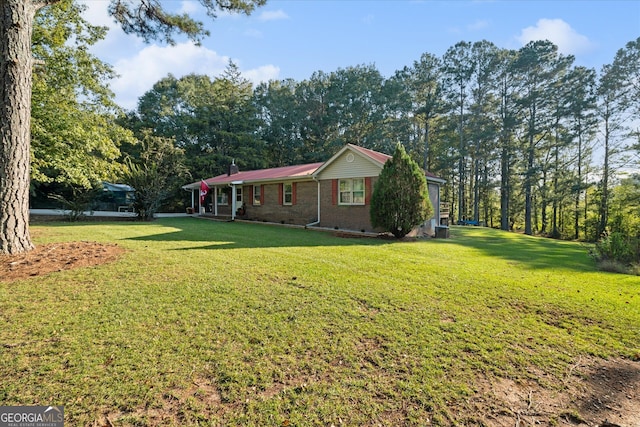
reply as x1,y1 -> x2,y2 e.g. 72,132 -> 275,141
0,0 -> 36,254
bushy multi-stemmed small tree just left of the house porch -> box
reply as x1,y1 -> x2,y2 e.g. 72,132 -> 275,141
124,131 -> 189,221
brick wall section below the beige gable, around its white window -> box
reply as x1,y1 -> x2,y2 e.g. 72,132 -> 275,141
319,177 -> 380,232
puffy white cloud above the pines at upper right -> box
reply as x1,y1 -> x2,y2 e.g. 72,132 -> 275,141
517,19 -> 593,55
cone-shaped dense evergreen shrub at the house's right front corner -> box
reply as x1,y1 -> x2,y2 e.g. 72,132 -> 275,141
370,144 -> 433,238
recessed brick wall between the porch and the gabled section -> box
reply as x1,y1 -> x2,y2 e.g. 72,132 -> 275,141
242,181 -> 318,225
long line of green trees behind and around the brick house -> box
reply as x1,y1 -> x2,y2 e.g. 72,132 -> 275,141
32,1 -> 640,240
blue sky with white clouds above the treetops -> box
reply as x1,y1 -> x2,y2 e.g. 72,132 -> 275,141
84,0 -> 640,109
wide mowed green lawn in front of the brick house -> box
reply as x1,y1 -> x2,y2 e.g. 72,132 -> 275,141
0,218 -> 640,426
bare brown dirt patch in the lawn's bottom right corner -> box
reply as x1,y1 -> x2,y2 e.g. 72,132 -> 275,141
466,359 -> 640,427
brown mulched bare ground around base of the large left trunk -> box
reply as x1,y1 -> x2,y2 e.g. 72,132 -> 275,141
0,242 -> 124,282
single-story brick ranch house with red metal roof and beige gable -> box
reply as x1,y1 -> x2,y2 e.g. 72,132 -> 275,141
182,144 -> 445,235
